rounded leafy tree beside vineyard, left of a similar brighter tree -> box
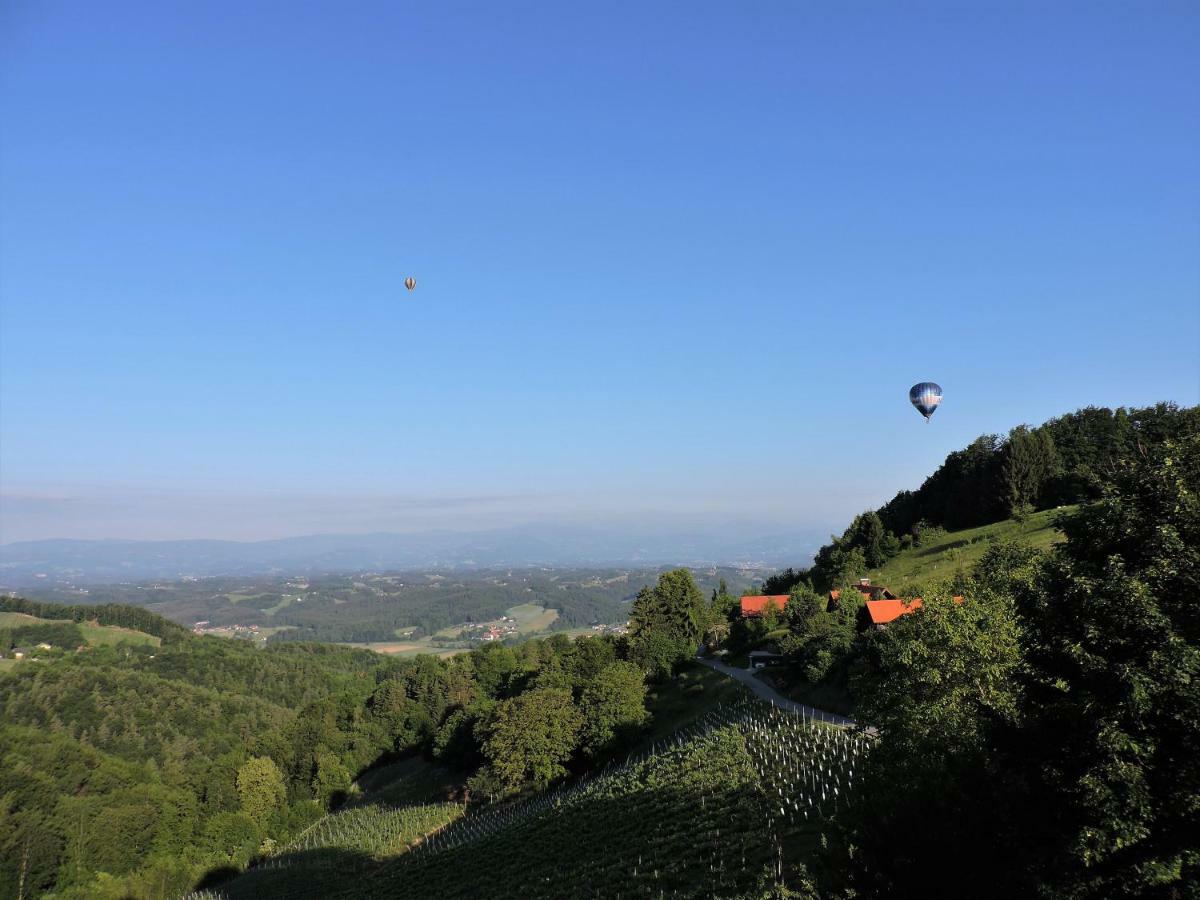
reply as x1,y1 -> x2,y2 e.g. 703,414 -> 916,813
478,689 -> 583,791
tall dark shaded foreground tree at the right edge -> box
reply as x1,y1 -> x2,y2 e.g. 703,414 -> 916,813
1010,428 -> 1200,896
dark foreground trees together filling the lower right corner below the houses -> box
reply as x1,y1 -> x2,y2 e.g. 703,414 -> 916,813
850,427 -> 1200,900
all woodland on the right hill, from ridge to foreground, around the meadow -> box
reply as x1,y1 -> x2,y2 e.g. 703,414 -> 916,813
707,406 -> 1200,898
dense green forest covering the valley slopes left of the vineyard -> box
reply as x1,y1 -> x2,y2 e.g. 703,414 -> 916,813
0,570 -> 707,898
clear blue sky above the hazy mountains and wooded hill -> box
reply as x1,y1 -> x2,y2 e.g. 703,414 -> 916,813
0,0 -> 1200,541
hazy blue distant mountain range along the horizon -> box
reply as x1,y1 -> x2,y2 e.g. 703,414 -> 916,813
0,526 -> 821,589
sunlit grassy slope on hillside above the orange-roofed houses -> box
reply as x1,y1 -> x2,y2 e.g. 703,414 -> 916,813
870,506 -> 1074,593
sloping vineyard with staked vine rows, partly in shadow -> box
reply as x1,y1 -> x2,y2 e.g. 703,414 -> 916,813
189,698 -> 866,900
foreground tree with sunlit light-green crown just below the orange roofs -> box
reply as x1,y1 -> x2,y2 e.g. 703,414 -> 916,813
850,592 -> 1028,898
